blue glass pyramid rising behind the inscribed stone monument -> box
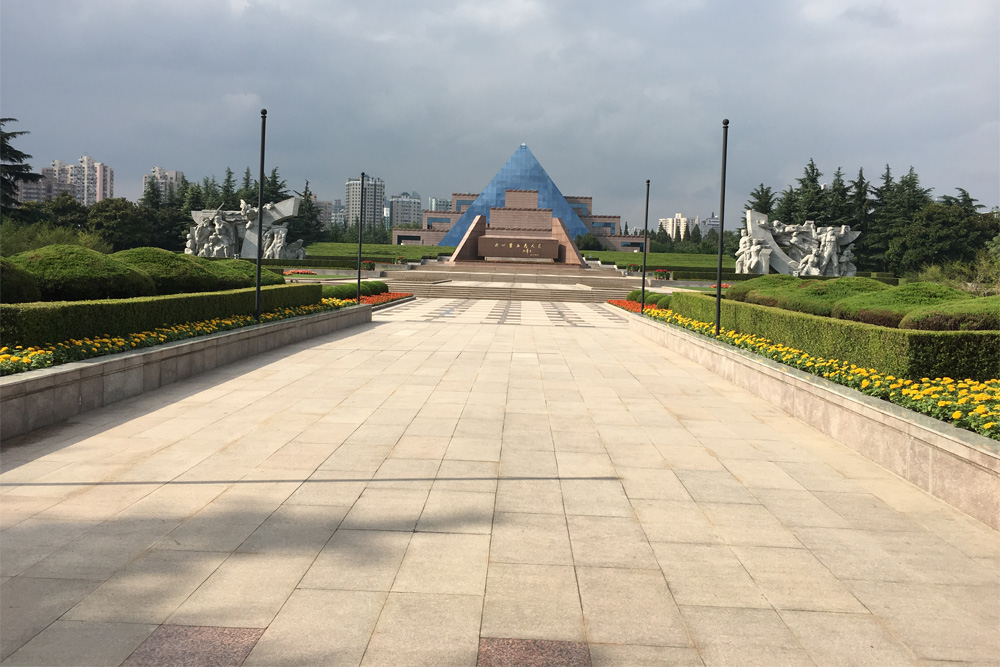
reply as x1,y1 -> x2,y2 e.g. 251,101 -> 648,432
438,144 -> 587,246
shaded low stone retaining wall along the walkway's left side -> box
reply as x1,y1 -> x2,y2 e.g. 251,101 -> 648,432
0,305 -> 372,446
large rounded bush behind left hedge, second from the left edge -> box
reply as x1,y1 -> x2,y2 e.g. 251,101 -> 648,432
10,245 -> 156,301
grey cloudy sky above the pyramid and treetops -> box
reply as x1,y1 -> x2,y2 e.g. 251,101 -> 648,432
0,0 -> 1000,227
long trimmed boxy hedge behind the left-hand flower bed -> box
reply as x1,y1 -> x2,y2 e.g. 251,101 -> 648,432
0,284 -> 322,347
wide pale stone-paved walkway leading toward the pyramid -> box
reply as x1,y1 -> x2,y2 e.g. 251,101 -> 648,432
0,300 -> 1000,666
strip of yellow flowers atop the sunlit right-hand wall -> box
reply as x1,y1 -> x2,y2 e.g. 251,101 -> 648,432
624,307 -> 1000,440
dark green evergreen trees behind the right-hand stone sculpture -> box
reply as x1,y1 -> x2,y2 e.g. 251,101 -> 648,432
744,159 -> 1000,275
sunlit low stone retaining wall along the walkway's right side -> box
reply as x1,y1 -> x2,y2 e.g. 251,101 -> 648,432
606,306 -> 1000,529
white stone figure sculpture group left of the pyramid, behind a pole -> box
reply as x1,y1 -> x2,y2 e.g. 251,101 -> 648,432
184,197 -> 306,259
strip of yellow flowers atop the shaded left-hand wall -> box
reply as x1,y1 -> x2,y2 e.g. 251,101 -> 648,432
0,299 -> 358,375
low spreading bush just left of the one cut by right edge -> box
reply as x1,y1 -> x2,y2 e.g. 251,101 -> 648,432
832,283 -> 974,327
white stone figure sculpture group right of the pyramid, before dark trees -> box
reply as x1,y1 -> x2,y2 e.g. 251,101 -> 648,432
736,211 -> 861,276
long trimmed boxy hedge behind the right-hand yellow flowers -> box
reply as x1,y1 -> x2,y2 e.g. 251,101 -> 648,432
670,292 -> 1000,380
